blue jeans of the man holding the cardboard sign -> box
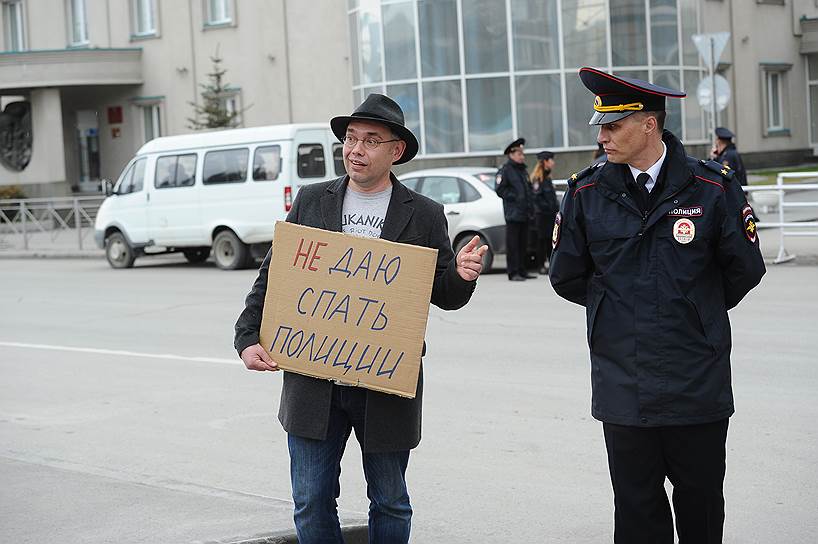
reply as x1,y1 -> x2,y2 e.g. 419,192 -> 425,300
287,385 -> 412,544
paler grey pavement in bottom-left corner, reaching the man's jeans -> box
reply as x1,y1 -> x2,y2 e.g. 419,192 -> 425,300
0,457 -> 367,544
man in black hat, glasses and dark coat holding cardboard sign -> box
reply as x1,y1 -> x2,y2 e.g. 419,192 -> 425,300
234,94 -> 488,544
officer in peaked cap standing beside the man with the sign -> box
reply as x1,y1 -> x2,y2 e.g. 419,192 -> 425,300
550,68 -> 765,544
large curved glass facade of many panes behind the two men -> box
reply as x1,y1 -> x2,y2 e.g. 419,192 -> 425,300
347,0 -> 704,157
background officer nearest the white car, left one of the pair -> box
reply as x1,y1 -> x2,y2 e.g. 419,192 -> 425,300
495,138 -> 536,281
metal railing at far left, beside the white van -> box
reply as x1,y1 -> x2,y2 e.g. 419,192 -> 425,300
0,196 -> 105,250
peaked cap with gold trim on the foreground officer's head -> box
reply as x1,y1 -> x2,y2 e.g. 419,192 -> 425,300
579,67 -> 687,125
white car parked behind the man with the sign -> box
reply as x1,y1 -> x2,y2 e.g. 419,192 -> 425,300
398,166 -> 506,271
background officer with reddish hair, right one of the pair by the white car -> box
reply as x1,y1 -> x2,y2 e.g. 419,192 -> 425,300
531,151 -> 560,275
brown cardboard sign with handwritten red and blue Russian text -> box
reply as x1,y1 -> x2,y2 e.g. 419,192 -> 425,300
260,221 -> 437,398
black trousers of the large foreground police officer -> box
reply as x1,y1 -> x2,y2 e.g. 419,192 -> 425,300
602,419 -> 728,544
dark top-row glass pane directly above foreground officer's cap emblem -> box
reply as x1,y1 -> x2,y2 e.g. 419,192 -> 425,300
611,0 -> 648,66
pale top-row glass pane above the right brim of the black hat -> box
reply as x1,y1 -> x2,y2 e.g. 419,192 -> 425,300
383,2 -> 417,80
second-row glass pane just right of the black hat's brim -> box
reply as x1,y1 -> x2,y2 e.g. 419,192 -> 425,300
423,81 -> 464,153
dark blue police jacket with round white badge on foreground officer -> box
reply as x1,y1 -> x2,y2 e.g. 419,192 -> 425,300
550,131 -> 765,427
